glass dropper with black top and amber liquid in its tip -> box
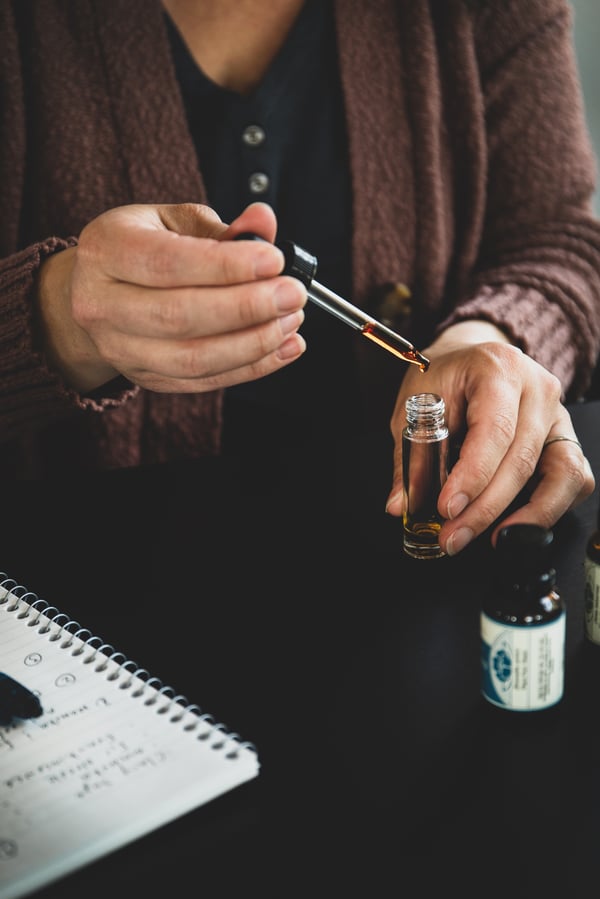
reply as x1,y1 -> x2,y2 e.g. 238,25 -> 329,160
235,234 -> 429,372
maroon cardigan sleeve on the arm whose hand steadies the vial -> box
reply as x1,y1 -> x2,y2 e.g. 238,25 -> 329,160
438,0 -> 600,398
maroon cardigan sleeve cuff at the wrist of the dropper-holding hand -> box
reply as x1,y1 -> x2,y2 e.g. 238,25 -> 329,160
0,237 -> 138,442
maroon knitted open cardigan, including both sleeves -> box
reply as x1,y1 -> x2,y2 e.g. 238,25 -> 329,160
0,0 -> 600,476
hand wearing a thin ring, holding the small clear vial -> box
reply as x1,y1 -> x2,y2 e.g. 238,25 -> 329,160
387,322 -> 595,555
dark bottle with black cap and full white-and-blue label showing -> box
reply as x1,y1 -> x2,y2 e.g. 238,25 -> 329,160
481,524 -> 566,712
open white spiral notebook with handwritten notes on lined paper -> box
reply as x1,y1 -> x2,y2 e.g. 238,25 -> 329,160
0,573 -> 259,899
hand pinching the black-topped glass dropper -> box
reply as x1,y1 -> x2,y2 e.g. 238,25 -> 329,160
38,203 -> 306,393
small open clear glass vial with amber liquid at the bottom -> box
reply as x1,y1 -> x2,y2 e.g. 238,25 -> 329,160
402,393 -> 448,559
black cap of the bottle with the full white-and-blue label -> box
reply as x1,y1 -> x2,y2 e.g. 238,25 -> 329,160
496,524 -> 556,586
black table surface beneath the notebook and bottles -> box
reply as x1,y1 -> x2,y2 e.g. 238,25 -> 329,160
0,402 -> 600,899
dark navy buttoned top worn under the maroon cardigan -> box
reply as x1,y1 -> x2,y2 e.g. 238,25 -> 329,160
167,0 -> 361,448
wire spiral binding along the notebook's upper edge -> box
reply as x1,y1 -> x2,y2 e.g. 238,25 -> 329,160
0,571 -> 257,759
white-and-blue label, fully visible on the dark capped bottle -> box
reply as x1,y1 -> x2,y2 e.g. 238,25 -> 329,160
481,610 -> 566,712
